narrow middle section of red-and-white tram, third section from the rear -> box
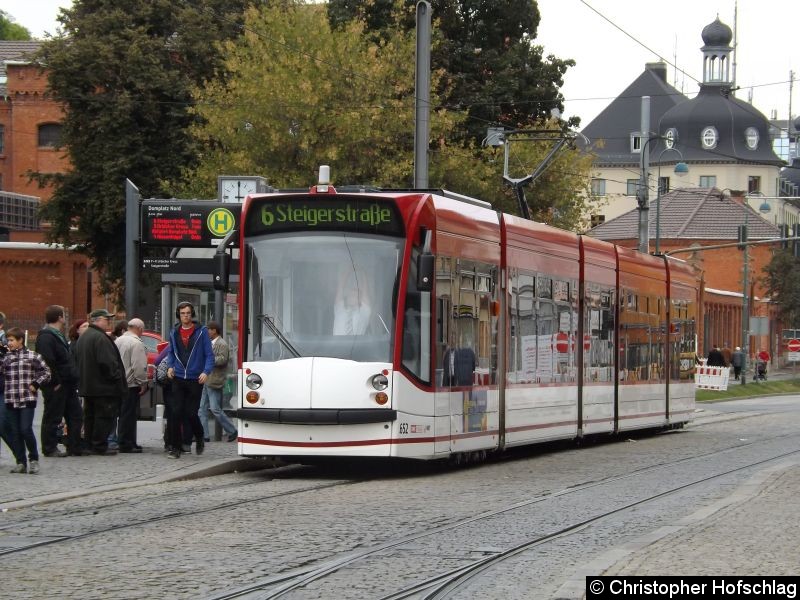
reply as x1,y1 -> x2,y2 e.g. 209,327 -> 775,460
581,236 -> 617,435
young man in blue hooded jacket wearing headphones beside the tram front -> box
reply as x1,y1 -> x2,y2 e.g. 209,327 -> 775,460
166,302 -> 214,458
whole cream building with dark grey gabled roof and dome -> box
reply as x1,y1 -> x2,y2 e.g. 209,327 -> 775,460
582,18 -> 798,225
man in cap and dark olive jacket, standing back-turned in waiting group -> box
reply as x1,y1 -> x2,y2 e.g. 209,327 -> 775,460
75,308 -> 128,456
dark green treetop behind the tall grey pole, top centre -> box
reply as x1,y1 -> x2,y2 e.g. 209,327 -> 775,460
328,0 -> 579,143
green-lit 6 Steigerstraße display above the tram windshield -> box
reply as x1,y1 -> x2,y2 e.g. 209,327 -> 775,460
245,196 -> 404,235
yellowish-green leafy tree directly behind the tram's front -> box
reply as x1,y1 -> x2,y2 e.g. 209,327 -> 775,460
181,2 -> 457,195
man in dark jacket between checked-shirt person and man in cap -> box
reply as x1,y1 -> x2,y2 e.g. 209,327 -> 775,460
36,304 -> 84,456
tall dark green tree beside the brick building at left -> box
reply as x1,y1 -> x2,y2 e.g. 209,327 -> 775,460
35,0 -> 252,298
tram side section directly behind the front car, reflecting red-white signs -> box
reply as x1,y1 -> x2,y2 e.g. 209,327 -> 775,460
504,215 -> 581,446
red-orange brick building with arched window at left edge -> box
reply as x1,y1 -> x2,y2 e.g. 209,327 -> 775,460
0,41 -> 107,333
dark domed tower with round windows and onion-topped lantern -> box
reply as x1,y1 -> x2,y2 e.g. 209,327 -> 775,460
651,17 -> 783,189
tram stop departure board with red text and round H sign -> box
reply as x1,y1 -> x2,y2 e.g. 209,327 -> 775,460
141,200 -> 241,248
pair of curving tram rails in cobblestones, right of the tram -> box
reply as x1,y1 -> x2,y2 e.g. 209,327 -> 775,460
209,434 -> 800,600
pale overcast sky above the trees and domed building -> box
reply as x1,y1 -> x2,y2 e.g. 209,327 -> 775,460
6,0 -> 800,126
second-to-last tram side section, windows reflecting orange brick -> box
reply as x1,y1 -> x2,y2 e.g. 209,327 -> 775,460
617,248 -> 668,430
